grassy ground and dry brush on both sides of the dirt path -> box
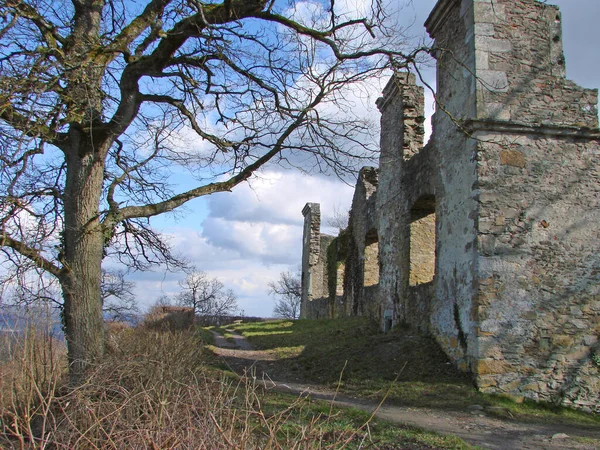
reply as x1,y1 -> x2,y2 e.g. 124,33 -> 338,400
0,319 -> 598,450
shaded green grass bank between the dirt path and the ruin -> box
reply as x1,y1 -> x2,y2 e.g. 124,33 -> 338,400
223,318 -> 600,429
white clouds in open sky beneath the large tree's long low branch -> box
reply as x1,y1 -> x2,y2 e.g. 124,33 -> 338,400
129,171 -> 353,317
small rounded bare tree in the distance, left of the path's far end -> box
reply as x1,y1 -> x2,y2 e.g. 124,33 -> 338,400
177,269 -> 237,321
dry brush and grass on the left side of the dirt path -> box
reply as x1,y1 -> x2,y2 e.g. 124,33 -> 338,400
0,320 -> 472,450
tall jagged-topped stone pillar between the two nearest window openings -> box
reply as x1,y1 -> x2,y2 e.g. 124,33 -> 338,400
377,74 -> 433,329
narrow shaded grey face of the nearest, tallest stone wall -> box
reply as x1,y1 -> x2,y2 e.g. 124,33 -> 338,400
425,0 -> 482,371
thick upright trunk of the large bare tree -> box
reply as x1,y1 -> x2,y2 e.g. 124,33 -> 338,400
60,0 -> 109,384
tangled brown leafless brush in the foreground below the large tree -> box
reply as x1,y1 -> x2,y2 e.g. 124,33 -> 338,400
0,328 -> 360,450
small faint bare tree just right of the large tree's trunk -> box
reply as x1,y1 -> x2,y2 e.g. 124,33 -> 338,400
100,269 -> 139,322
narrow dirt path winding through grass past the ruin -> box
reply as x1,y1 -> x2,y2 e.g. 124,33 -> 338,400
213,330 -> 600,450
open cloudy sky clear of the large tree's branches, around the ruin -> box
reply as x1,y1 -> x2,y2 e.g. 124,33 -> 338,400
128,0 -> 600,317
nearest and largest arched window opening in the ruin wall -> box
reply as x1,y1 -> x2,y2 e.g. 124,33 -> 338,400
409,195 -> 435,286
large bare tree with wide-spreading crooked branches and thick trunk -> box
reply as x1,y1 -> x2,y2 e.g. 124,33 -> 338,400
0,0 -> 424,382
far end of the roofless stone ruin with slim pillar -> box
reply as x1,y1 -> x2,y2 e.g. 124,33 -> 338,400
300,167 -> 379,319
